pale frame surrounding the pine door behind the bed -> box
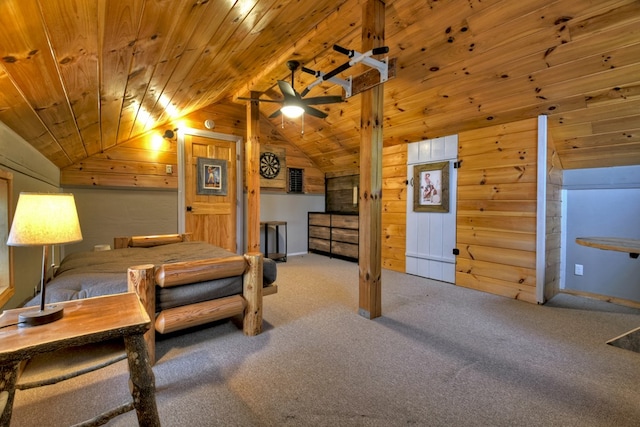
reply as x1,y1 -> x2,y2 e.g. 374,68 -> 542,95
177,128 -> 245,254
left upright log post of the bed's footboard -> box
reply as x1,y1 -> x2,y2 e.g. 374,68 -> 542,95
127,264 -> 156,365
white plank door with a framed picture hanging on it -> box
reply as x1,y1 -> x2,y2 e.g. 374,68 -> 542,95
406,135 -> 458,283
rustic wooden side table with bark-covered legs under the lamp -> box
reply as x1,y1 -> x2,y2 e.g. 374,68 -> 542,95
0,293 -> 160,426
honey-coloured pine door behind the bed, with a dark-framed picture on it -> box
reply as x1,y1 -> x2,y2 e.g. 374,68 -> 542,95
184,135 -> 237,252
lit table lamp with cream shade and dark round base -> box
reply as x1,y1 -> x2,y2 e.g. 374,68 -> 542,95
7,193 -> 82,326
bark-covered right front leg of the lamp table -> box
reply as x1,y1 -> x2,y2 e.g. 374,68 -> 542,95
124,335 -> 160,427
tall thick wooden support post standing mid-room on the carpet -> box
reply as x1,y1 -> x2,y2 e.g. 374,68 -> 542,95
358,0 -> 385,319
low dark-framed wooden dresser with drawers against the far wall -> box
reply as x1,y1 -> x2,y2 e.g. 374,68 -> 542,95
308,212 -> 358,261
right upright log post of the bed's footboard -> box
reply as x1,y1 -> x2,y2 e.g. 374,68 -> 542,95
242,252 -> 264,336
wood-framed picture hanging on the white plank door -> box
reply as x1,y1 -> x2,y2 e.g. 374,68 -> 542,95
413,162 -> 449,212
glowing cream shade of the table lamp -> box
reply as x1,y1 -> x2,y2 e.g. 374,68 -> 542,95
7,193 -> 82,246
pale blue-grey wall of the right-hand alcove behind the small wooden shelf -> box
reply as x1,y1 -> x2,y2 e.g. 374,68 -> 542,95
563,166 -> 640,301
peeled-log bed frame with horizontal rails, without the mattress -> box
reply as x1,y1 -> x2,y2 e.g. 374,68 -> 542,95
113,234 -> 278,364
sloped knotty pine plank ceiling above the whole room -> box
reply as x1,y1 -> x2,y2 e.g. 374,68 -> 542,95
0,0 -> 640,172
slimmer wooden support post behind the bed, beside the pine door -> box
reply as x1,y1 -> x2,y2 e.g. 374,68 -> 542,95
245,92 -> 260,253
